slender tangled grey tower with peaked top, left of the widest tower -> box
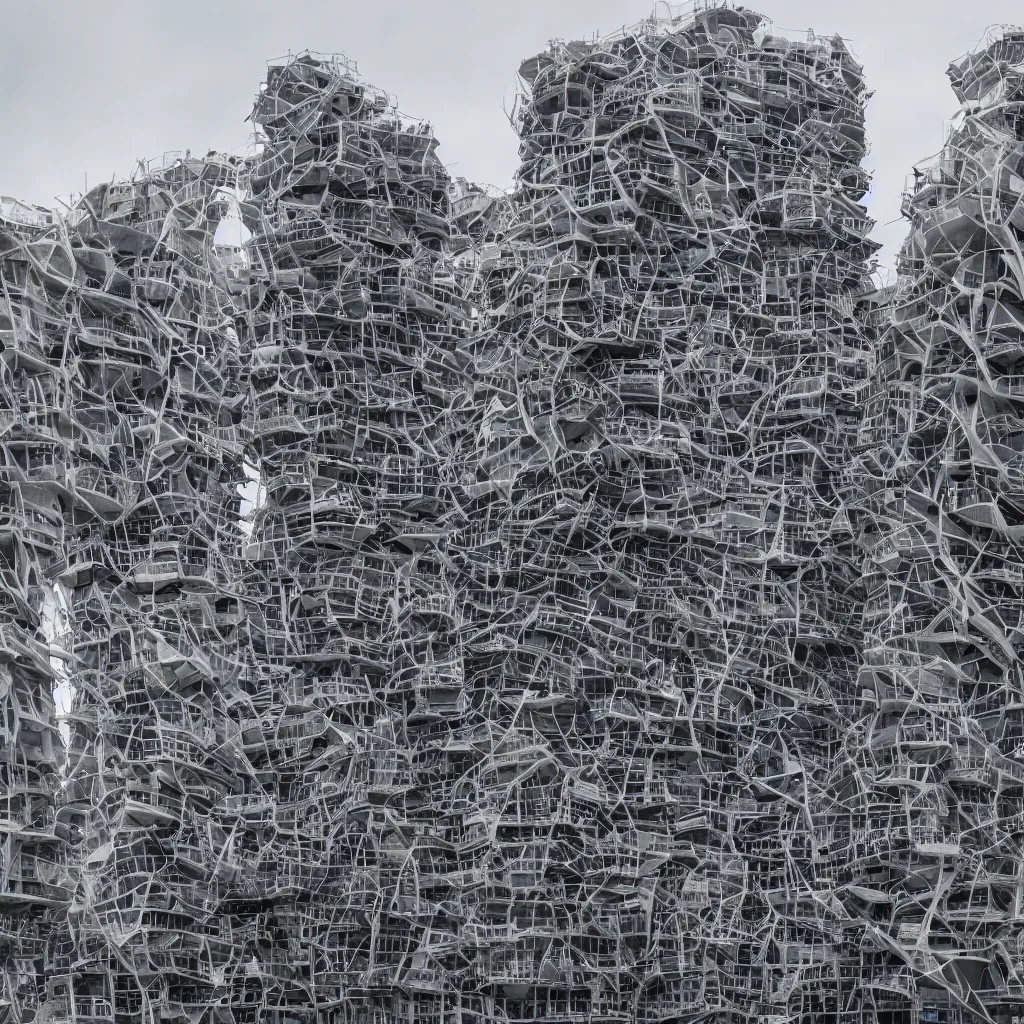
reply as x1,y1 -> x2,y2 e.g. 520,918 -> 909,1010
236,54 -> 472,1024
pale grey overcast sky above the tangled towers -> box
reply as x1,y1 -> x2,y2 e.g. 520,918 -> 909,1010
0,0 -> 1024,272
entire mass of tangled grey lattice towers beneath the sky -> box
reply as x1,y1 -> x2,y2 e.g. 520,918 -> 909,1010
6,8 -> 1024,1024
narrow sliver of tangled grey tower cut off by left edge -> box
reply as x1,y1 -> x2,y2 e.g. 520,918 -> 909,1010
0,197 -> 75,1024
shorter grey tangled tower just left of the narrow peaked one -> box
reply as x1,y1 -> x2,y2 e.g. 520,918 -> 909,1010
47,156 -> 253,1024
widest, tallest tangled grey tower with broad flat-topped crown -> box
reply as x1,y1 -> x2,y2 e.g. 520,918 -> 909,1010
462,5 -> 876,1022
